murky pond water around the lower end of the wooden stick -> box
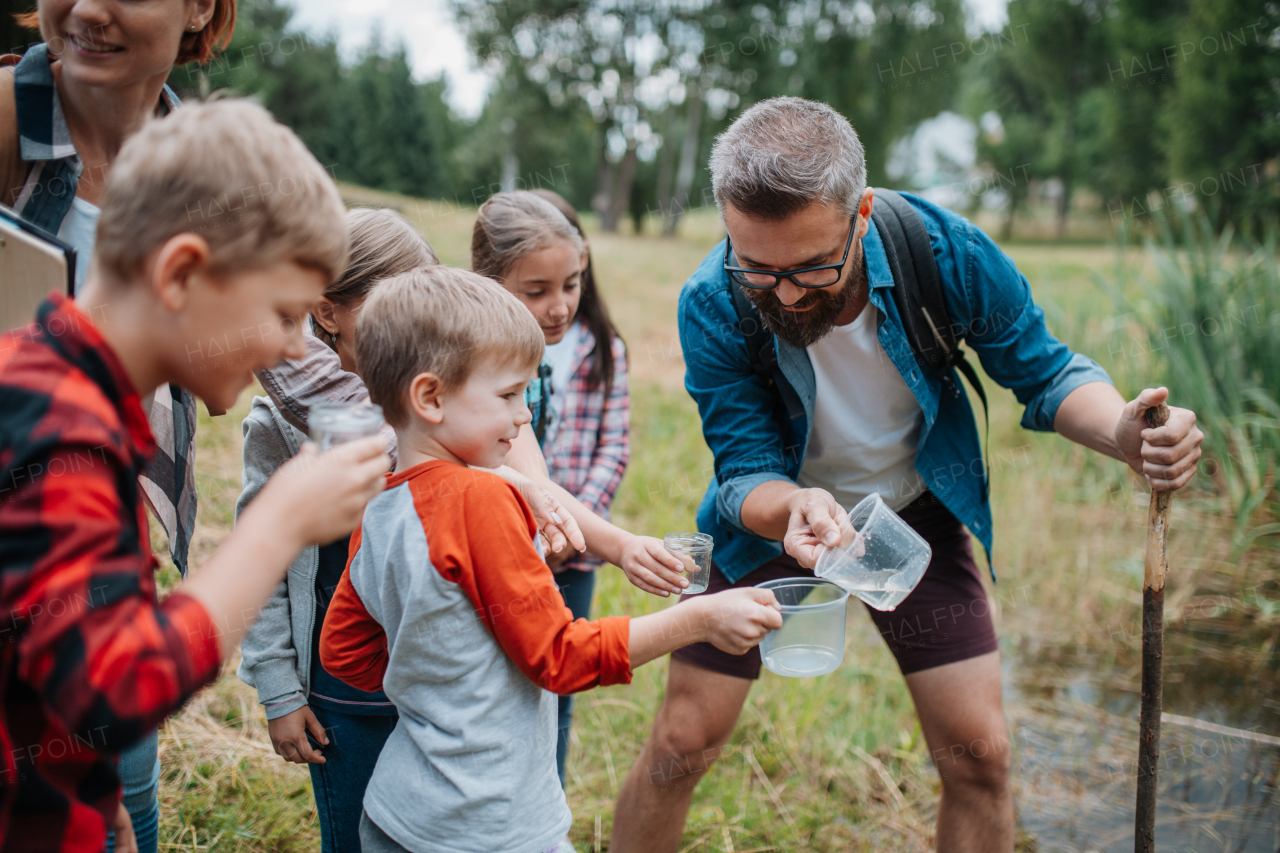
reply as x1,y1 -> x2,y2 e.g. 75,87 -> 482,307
1005,629 -> 1280,853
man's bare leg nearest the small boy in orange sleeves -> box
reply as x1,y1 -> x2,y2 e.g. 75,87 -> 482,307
609,657 -> 751,853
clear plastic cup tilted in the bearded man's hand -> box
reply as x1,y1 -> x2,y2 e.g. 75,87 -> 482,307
813,494 -> 933,610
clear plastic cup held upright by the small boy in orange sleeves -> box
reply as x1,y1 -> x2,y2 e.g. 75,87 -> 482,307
756,578 -> 849,679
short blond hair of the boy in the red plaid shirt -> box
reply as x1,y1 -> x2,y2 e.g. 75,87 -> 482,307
93,100 -> 347,280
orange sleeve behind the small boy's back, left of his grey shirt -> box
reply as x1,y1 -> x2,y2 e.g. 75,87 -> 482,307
320,528 -> 387,693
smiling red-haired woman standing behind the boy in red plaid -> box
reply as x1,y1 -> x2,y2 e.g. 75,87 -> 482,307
0,0 -> 236,853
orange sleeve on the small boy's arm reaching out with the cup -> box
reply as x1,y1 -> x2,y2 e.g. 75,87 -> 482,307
424,470 -> 631,694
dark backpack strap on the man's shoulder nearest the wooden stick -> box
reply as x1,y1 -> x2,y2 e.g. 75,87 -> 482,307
872,188 -> 991,500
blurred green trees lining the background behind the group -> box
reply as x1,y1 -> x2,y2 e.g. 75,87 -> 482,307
0,0 -> 1280,233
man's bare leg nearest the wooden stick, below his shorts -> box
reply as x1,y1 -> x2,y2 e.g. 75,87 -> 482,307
906,652 -> 1014,853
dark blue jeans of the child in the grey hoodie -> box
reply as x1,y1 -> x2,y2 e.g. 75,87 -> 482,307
307,704 -> 399,853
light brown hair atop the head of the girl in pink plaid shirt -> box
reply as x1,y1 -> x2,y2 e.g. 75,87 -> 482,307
471,190 -> 586,282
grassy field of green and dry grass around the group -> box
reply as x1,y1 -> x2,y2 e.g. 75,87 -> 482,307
145,190 -> 1280,853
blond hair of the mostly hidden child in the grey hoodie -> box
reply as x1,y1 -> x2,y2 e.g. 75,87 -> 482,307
324,207 -> 440,305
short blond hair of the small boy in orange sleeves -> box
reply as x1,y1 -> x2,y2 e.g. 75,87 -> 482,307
356,266 -> 544,428
